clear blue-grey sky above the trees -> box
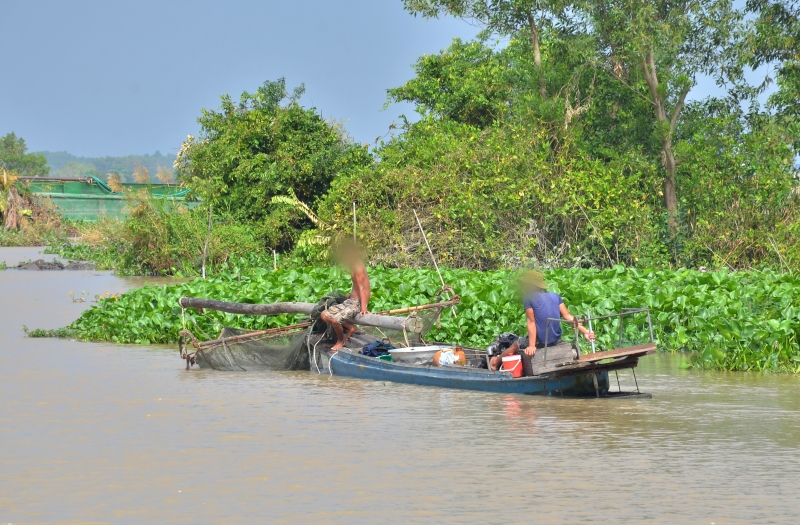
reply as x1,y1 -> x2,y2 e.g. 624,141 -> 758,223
0,0 -> 776,157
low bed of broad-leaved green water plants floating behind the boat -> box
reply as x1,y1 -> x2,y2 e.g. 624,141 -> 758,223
59,258 -> 800,372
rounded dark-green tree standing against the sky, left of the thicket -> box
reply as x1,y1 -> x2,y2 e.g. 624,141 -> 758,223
176,79 -> 371,249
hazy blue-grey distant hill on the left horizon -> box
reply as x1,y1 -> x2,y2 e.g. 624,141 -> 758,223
38,151 -> 175,184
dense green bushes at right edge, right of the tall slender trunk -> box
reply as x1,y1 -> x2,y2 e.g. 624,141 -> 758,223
676,100 -> 800,269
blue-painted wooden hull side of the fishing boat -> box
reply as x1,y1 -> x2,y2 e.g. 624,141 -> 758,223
329,352 -> 608,397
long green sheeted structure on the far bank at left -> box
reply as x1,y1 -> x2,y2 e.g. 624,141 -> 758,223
20,175 -> 199,221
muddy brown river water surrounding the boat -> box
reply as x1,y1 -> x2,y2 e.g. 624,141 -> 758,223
0,249 -> 800,524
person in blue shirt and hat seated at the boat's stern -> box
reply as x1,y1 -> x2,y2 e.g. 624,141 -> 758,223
489,271 -> 594,370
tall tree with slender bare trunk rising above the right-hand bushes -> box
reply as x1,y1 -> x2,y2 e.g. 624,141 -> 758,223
583,0 -> 742,234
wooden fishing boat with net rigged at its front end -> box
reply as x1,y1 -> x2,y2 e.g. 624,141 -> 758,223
181,297 -> 656,399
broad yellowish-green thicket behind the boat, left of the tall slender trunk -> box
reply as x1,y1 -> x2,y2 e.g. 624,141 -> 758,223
319,110 -> 665,269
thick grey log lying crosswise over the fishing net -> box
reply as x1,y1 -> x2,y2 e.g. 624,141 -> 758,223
178,297 -> 422,332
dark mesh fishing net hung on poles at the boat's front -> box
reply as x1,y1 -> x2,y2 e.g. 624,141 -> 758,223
179,295 -> 458,372
